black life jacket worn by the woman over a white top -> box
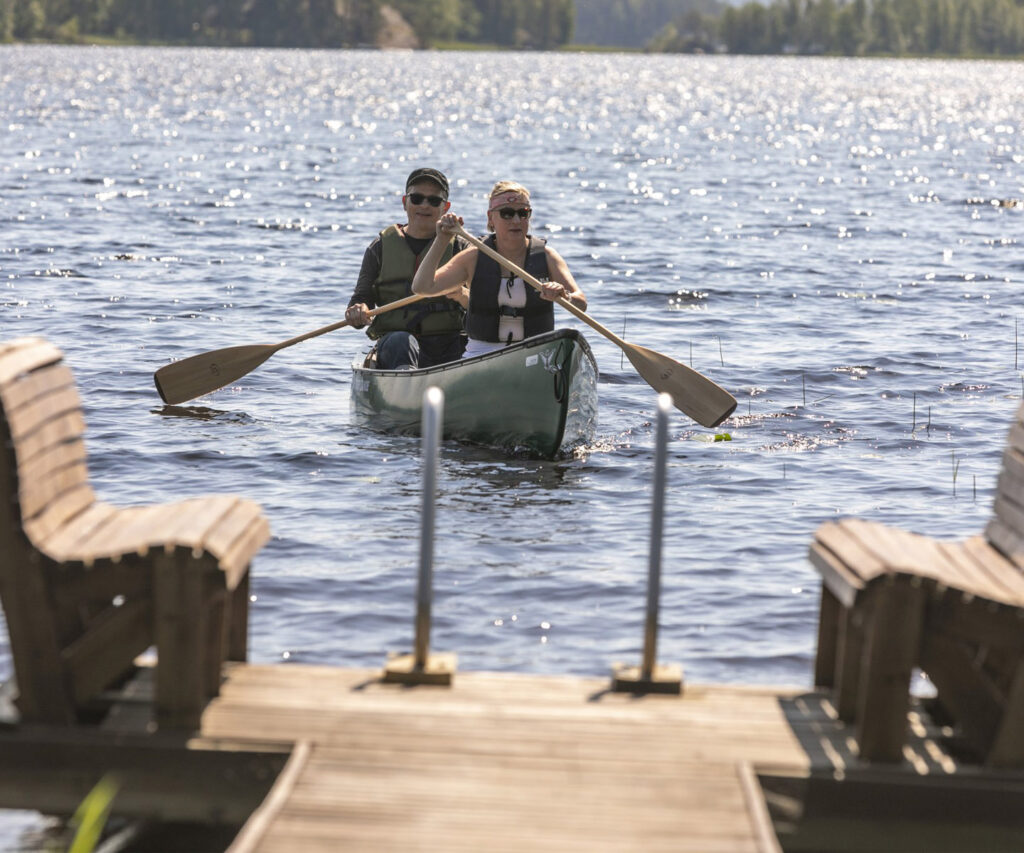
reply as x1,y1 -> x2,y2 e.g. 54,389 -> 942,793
466,234 -> 555,343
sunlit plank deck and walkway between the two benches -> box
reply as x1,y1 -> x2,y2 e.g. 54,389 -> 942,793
203,665 -> 808,853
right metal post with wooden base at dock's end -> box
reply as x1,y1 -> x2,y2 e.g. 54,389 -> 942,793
611,393 -> 683,693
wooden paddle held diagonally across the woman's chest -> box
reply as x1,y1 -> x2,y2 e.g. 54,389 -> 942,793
456,226 -> 736,427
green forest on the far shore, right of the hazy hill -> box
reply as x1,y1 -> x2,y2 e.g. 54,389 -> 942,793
648,0 -> 1024,56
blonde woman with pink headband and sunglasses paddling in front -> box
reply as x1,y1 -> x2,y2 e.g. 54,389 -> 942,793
413,180 -> 587,358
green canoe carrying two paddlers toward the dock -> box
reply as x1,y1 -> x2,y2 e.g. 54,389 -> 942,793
352,329 -> 597,459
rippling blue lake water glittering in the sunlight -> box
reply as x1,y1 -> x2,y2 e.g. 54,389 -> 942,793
0,46 -> 1024,850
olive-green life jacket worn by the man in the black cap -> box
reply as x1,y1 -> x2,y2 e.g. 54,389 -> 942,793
367,225 -> 466,340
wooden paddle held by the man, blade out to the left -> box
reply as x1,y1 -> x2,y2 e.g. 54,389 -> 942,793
153,293 -> 428,404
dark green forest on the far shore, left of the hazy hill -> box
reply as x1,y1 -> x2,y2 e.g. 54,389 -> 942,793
0,0 -> 574,49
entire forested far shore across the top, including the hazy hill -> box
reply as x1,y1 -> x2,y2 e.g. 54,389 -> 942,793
6,0 -> 1024,56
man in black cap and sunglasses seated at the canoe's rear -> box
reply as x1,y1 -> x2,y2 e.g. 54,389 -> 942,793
345,168 -> 469,370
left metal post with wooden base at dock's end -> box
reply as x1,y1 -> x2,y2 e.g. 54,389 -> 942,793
383,386 -> 456,685
